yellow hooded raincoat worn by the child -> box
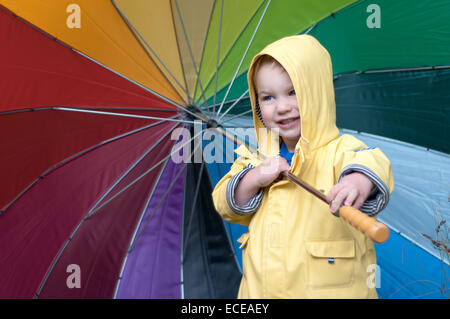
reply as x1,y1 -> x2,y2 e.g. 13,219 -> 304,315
213,35 -> 393,298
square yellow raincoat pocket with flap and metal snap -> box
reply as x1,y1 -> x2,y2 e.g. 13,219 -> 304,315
306,239 -> 356,288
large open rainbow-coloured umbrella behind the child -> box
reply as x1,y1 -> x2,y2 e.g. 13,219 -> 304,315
0,0 -> 450,298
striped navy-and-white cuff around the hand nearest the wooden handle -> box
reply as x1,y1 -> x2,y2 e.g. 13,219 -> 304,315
339,164 -> 389,217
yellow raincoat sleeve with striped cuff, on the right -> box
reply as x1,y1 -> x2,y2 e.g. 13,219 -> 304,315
334,135 -> 394,217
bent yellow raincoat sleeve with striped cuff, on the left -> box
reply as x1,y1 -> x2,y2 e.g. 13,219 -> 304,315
212,158 -> 263,226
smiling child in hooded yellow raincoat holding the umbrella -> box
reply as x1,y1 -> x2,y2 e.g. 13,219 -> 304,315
213,35 -> 393,298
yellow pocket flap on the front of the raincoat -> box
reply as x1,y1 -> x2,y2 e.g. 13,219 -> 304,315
306,239 -> 355,258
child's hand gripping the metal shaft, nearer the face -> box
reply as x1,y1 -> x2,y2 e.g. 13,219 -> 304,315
252,155 -> 291,187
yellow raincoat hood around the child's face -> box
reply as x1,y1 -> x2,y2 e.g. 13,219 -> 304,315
247,35 -> 339,162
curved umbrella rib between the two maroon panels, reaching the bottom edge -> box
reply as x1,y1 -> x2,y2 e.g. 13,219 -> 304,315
35,124 -> 178,298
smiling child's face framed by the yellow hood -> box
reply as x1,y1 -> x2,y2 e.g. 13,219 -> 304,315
255,63 -> 301,152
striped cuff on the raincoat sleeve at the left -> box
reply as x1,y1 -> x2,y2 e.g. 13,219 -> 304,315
226,164 -> 263,215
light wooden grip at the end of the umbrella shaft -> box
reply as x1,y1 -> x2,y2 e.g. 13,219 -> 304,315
339,206 -> 389,244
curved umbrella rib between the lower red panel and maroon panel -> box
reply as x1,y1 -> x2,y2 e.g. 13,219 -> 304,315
0,116 -> 176,215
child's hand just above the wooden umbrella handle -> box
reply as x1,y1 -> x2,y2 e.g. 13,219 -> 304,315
327,172 -> 374,214
